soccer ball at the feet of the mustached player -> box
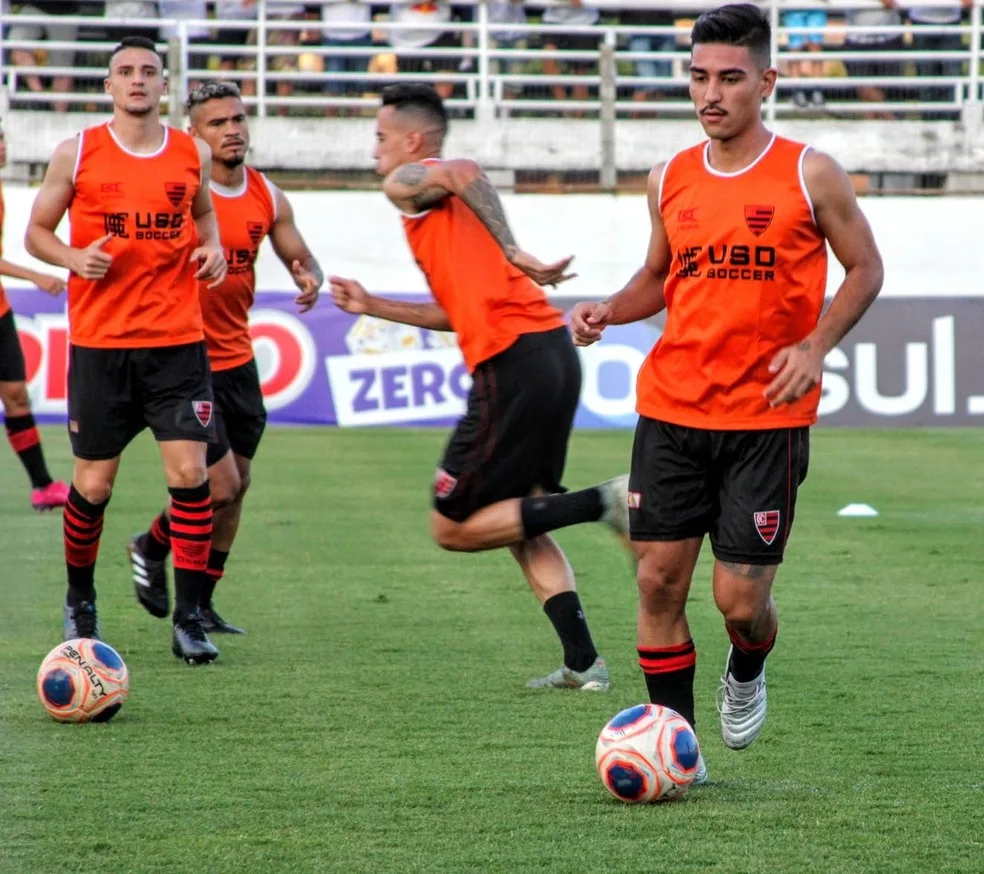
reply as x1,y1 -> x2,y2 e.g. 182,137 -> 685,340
595,704 -> 700,804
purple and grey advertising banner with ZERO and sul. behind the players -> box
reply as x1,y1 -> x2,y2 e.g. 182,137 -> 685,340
8,289 -> 984,428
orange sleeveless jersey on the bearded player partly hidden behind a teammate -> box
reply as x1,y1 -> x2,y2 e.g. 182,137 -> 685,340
199,167 -> 277,370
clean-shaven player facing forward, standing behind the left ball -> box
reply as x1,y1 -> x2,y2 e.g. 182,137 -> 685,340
25,37 -> 226,662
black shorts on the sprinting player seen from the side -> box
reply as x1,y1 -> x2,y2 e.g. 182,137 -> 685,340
434,328 -> 581,522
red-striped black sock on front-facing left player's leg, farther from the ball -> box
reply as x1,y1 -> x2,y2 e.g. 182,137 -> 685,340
168,480 -> 212,622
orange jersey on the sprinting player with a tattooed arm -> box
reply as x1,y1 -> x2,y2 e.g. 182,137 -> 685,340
403,181 -> 564,371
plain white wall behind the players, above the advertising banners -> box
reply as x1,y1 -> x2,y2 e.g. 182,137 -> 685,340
3,184 -> 984,297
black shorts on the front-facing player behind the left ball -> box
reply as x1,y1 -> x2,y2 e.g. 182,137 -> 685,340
68,341 -> 215,461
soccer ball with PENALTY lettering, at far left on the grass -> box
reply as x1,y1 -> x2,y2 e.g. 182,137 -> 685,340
38,638 -> 130,722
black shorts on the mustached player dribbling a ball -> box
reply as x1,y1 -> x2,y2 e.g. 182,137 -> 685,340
629,416 -> 810,564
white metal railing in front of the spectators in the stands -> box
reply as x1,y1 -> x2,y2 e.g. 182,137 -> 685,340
0,0 -> 984,120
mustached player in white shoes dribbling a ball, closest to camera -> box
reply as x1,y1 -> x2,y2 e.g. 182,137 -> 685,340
572,4 -> 883,779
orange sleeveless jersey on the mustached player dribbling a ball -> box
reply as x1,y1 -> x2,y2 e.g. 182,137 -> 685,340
636,137 -> 827,430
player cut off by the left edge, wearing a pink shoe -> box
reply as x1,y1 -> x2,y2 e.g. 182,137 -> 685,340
0,121 -> 68,512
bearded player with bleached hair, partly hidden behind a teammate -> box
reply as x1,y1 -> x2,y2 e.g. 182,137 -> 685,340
128,82 -> 324,634
